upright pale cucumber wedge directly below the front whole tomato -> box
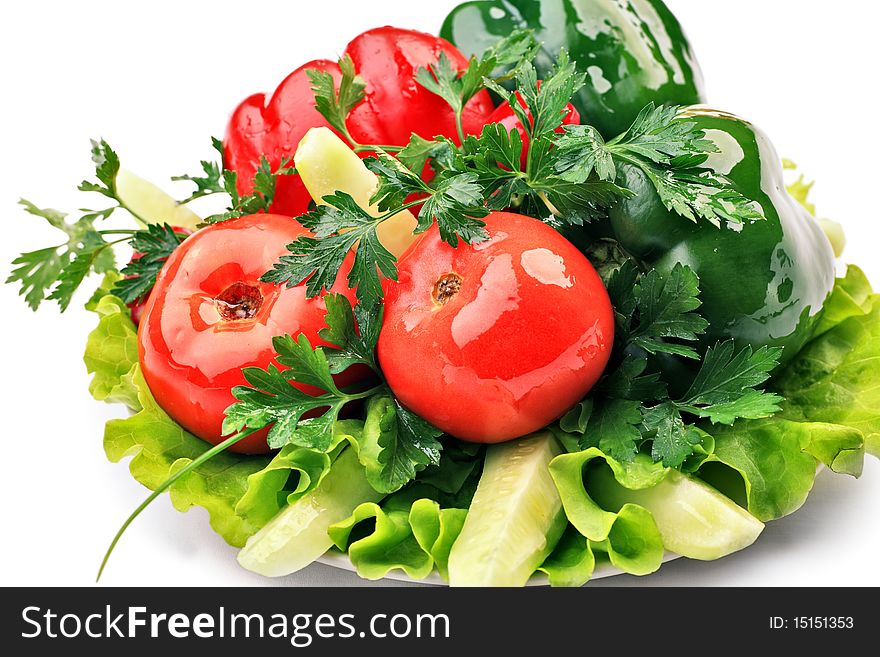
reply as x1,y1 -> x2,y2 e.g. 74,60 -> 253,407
449,431 -> 566,586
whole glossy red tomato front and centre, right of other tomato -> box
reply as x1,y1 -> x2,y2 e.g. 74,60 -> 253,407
378,212 -> 614,443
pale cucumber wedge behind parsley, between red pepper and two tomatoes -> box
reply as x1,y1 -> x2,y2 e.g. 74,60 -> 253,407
293,127 -> 416,257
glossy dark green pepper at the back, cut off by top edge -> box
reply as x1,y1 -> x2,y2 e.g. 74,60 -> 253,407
440,0 -> 705,138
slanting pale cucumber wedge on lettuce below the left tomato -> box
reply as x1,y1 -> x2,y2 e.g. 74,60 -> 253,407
238,447 -> 384,577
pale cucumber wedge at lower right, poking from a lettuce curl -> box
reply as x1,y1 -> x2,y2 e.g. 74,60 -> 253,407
586,466 -> 764,561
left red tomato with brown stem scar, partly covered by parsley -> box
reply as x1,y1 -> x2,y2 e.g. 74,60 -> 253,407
138,214 -> 354,454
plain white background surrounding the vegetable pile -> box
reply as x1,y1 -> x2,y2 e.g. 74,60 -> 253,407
0,0 -> 880,586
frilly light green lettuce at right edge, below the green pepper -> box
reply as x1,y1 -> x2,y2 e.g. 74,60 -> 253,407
699,265 -> 880,521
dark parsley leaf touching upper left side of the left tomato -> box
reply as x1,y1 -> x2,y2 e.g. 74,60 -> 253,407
112,224 -> 186,303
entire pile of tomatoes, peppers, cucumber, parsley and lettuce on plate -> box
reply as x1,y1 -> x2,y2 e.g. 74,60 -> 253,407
8,0 -> 880,586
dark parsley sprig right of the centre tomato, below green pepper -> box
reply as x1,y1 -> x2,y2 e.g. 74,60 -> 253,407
560,261 -> 782,467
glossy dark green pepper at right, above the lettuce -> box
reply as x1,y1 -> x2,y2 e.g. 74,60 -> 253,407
609,107 -> 835,359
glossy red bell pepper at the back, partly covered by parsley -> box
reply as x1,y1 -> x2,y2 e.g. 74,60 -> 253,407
223,27 -> 494,216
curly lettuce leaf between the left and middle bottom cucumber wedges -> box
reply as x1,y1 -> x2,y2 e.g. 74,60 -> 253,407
329,499 -> 467,580
